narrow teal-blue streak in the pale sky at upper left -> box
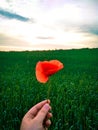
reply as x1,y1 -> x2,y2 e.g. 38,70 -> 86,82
0,9 -> 30,22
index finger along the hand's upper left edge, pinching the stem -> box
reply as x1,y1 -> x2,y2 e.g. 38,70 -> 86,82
26,100 -> 50,118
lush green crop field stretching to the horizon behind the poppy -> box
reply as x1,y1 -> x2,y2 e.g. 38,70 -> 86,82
0,49 -> 98,130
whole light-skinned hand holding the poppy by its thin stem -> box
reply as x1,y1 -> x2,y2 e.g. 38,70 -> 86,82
20,100 -> 52,130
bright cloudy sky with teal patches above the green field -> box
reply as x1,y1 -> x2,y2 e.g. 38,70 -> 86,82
0,0 -> 98,51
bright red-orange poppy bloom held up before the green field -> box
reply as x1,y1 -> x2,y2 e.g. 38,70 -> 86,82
36,60 -> 63,83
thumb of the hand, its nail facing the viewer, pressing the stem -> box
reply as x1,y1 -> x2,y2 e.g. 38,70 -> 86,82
36,103 -> 51,122
